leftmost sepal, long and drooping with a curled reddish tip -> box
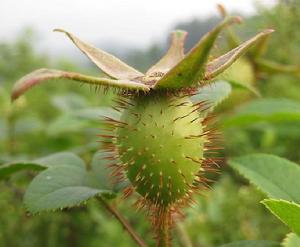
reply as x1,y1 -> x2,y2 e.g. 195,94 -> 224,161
11,69 -> 150,100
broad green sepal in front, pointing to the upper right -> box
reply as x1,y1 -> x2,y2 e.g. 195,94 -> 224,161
154,17 -> 240,89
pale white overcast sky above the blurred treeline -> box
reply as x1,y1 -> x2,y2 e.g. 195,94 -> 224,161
0,0 -> 276,53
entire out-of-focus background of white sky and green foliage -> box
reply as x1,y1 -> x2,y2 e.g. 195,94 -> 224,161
0,0 -> 300,247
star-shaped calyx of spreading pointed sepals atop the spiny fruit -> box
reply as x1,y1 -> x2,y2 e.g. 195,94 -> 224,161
11,17 -> 273,100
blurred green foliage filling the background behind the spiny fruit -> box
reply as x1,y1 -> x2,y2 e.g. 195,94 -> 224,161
0,0 -> 300,247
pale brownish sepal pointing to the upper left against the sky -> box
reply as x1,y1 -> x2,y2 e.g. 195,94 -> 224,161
54,29 -> 143,79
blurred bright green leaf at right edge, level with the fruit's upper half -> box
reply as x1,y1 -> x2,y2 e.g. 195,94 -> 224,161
223,99 -> 300,127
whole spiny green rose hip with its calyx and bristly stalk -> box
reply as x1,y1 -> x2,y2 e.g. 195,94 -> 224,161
12,14 -> 272,246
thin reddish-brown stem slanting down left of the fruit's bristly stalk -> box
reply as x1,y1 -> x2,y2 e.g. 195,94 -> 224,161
98,197 -> 147,247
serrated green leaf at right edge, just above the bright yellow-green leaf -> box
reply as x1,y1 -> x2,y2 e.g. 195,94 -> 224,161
228,154 -> 300,203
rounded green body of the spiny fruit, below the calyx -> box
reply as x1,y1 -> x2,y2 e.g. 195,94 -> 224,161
116,93 -> 205,206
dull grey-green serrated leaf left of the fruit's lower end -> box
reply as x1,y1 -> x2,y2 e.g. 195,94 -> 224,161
24,166 -> 111,213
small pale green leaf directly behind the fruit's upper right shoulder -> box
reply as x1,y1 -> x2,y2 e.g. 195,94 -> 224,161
191,81 -> 232,115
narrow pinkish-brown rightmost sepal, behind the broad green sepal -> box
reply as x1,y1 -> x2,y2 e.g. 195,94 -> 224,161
205,29 -> 273,80
